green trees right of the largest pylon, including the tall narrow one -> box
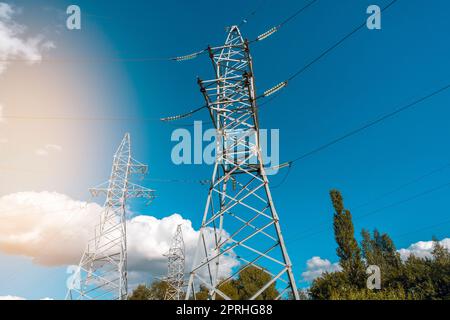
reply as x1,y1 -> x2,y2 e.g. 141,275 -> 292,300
309,190 -> 450,300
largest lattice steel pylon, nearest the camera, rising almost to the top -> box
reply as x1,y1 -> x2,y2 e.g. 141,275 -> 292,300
185,26 -> 298,300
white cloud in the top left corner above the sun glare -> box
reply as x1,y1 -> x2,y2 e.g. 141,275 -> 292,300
0,2 -> 54,74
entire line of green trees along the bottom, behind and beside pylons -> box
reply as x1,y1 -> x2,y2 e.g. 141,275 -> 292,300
129,190 -> 450,300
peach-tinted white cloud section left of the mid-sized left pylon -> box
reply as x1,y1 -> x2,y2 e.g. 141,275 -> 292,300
0,192 -> 101,265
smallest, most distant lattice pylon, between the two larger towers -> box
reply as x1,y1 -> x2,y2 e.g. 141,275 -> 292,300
164,225 -> 185,300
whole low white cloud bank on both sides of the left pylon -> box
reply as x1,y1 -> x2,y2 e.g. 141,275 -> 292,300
0,192 -> 237,283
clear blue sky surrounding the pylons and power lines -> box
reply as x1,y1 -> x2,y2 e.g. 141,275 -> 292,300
0,0 -> 450,298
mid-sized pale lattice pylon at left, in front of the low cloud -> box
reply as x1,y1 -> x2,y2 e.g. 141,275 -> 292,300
66,133 -> 155,300
